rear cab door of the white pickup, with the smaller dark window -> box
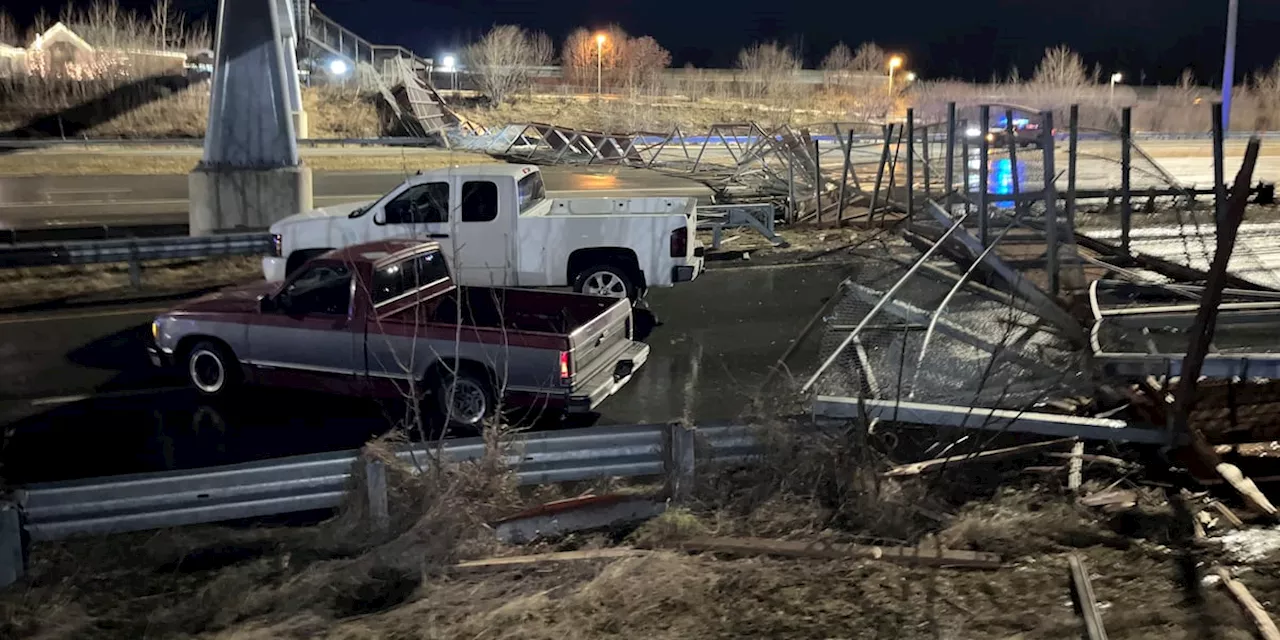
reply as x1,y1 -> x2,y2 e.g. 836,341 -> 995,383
426,178 -> 516,287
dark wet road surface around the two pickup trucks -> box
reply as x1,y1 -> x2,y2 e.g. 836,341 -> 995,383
0,264 -> 847,481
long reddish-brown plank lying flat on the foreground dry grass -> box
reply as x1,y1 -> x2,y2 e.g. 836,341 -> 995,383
675,536 -> 1001,568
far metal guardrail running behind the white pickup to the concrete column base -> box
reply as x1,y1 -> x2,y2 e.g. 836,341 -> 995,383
0,232 -> 271,269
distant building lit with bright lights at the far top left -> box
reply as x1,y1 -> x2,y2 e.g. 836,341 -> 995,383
0,22 -> 187,81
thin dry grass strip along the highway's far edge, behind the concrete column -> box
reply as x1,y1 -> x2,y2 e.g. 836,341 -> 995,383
0,145 -> 497,177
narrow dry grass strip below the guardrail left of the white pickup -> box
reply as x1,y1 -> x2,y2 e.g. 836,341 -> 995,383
0,257 -> 262,308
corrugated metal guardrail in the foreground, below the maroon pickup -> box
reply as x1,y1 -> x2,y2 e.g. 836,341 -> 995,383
18,425 -> 756,540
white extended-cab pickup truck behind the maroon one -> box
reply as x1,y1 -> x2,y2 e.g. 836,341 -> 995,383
262,164 -> 703,300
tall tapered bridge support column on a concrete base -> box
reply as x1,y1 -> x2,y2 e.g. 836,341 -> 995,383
188,0 -> 312,236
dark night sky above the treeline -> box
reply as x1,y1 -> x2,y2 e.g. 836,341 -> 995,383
9,0 -> 1280,84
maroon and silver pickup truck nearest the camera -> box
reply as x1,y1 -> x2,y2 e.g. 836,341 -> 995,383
147,241 -> 649,428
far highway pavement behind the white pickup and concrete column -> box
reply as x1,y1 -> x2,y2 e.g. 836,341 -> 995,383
0,166 -> 710,230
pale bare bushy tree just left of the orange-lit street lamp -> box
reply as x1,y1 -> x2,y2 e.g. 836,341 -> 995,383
462,24 -> 552,102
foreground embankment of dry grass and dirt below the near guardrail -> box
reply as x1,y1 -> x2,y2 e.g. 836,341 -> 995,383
0,426 -> 1280,640
